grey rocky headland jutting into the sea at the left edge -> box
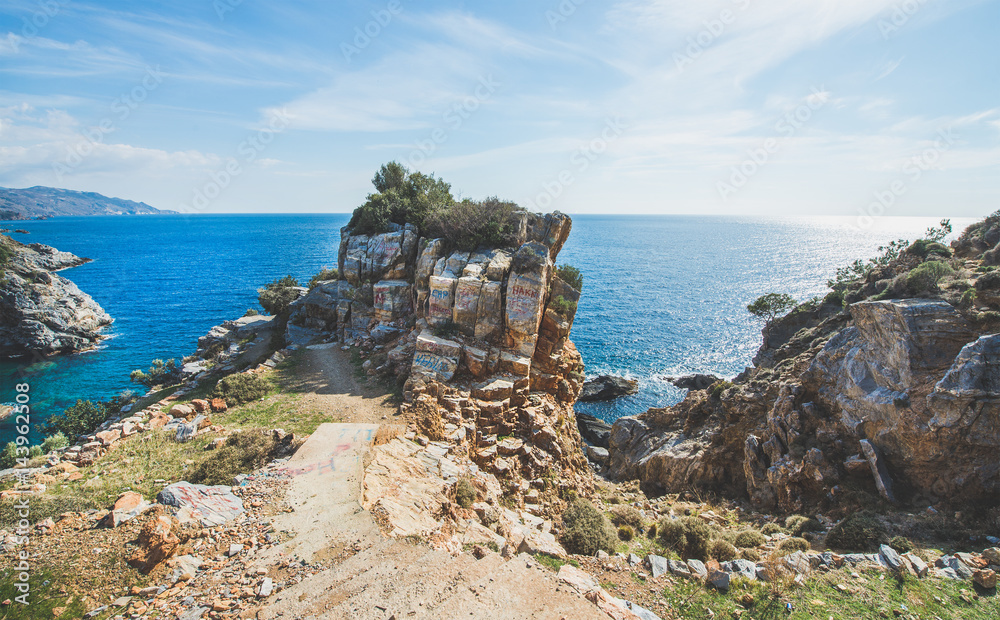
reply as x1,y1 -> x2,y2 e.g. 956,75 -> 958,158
0,237 -> 112,357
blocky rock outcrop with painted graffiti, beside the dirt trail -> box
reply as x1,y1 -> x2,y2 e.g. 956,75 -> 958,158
287,212 -> 590,516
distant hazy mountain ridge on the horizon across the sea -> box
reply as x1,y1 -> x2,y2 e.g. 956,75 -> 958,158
0,186 -> 176,220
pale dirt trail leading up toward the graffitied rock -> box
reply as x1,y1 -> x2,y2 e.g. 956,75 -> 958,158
258,348 -> 607,620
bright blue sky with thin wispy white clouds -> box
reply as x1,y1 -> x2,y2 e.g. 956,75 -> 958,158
0,0 -> 1000,218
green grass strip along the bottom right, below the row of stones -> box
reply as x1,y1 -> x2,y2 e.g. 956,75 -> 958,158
663,569 -> 1000,620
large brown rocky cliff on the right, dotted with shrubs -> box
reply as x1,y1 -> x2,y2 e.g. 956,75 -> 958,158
609,218 -> 1000,512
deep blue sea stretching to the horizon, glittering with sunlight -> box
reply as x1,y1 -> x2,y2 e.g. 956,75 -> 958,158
0,214 -> 971,445
